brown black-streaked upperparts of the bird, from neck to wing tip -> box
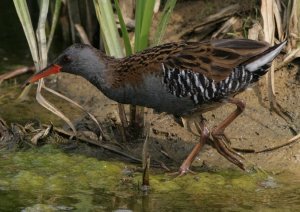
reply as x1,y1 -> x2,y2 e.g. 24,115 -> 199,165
108,39 -> 269,87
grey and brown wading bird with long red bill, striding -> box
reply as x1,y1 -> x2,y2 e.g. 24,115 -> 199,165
26,39 -> 287,175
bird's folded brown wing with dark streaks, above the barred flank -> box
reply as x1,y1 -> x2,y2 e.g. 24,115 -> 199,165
164,39 -> 269,81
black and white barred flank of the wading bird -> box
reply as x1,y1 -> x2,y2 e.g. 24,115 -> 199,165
162,64 -> 260,104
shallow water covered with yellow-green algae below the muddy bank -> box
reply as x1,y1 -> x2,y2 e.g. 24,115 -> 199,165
0,145 -> 300,211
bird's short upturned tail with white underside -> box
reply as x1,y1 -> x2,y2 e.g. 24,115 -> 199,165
244,40 -> 287,76
